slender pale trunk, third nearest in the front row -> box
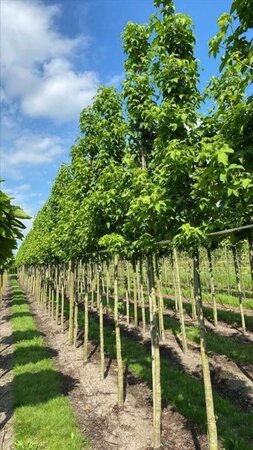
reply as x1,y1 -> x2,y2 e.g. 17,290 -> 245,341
114,255 -> 124,406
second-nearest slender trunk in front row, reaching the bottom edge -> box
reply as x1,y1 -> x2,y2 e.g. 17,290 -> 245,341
147,256 -> 161,449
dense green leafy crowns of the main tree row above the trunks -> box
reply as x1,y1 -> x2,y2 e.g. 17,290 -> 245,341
17,0 -> 253,264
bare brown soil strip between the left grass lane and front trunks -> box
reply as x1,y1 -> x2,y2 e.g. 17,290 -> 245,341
26,290 -> 207,450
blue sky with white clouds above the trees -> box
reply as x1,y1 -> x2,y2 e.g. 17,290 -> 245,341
0,0 -> 231,234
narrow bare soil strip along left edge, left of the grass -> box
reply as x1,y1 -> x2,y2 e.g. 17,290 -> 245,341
0,291 -> 13,450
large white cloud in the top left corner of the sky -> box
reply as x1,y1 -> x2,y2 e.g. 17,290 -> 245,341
1,0 -> 98,121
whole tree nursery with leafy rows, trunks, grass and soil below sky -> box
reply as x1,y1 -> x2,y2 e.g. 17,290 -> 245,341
0,0 -> 253,450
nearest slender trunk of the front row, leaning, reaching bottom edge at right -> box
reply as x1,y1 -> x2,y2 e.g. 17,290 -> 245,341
193,250 -> 218,450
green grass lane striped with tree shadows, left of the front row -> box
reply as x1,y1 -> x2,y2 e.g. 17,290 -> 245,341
11,280 -> 89,450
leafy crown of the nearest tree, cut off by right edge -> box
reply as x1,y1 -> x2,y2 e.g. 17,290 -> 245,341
204,0 -> 253,232
